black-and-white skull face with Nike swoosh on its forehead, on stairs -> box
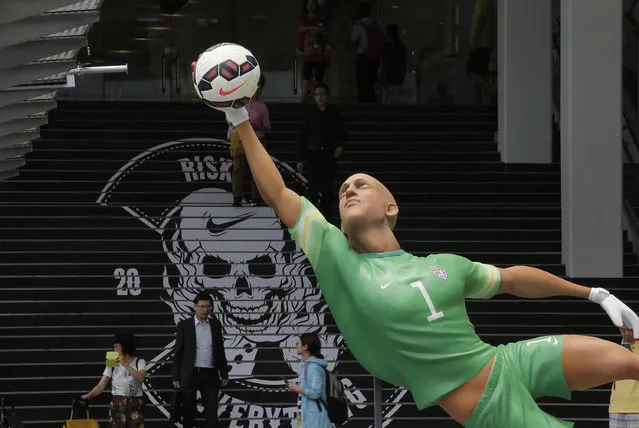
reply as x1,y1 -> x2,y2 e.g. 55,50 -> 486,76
162,188 -> 337,382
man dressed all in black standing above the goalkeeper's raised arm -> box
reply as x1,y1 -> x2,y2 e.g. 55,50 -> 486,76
297,83 -> 346,221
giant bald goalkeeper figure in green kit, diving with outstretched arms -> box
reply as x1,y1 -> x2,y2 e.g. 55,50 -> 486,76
225,102 -> 639,428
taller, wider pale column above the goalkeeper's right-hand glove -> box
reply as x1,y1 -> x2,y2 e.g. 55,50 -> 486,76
561,0 -> 623,278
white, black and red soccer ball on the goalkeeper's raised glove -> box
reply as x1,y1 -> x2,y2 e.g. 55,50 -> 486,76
192,43 -> 260,110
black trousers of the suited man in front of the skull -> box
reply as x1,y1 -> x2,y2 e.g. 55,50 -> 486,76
182,367 -> 220,428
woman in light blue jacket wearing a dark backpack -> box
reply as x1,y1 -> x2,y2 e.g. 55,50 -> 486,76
286,333 -> 333,428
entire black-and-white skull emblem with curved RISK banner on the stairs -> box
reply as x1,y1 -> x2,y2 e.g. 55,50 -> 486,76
97,139 -> 406,428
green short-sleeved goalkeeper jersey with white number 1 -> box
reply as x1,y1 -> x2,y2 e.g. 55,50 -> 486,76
290,198 -> 501,409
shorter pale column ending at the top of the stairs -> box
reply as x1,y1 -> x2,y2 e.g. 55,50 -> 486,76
497,0 -> 552,163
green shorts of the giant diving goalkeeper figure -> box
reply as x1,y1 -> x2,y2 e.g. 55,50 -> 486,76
464,336 -> 574,428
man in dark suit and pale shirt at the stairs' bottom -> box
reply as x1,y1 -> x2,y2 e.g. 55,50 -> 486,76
173,293 -> 229,428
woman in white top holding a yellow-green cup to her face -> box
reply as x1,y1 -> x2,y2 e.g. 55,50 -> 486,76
82,333 -> 146,428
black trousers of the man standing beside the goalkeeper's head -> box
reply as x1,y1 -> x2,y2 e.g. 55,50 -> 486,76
306,152 -> 336,222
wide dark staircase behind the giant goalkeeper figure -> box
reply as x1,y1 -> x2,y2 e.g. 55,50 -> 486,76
0,102 -> 639,427
